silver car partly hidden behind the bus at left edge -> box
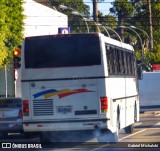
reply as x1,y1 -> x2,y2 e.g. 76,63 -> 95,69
0,98 -> 23,137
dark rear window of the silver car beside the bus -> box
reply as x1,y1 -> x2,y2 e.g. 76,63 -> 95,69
0,98 -> 22,109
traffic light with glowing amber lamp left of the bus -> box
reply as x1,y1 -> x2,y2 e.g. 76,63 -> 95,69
13,48 -> 21,69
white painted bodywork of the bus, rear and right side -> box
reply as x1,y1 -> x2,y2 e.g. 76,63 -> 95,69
22,34 -> 139,138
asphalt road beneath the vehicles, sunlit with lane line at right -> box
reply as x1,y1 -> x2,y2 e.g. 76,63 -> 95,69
0,111 -> 160,151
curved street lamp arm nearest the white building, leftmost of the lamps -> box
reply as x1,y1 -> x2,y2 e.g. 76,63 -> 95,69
59,5 -> 89,33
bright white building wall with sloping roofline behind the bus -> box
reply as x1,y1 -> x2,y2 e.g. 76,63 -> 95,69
23,0 -> 68,37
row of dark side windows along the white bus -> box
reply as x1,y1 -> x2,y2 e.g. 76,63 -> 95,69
106,44 -> 135,76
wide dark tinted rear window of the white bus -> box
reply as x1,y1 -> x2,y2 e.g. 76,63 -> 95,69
25,34 -> 101,68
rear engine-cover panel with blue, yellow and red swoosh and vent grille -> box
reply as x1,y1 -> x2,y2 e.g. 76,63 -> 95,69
30,80 -> 99,120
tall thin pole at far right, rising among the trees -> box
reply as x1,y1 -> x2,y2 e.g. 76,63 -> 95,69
147,0 -> 153,50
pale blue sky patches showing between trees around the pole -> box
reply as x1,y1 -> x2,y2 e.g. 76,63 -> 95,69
83,0 -> 114,15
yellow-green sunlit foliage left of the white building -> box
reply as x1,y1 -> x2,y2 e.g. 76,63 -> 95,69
0,0 -> 24,68
